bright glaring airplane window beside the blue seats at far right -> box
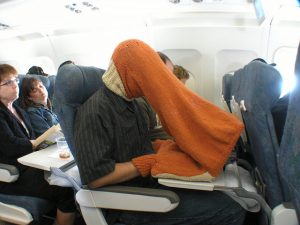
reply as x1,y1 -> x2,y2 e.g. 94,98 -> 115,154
273,47 -> 297,96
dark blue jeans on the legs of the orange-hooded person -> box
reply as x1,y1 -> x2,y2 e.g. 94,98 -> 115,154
118,179 -> 246,225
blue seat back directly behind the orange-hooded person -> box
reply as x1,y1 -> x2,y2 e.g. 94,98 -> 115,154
53,64 -> 105,159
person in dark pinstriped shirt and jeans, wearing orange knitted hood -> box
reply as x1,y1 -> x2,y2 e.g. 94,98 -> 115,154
74,40 -> 245,225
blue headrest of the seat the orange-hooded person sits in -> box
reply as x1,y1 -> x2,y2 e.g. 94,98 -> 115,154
55,64 -> 105,104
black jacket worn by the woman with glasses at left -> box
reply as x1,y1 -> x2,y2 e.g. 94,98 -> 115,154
0,102 -> 35,172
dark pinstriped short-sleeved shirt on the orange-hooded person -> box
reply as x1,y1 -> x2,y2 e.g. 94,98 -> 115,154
74,87 -> 153,184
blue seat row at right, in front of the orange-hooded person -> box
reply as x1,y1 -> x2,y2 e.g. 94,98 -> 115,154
223,54 -> 300,225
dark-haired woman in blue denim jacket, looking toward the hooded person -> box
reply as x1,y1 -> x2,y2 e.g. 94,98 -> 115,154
19,77 -> 58,137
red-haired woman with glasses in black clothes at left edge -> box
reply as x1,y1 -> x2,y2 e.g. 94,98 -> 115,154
0,64 -> 76,225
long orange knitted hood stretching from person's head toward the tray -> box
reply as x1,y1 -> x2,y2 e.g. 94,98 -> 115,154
112,39 -> 243,176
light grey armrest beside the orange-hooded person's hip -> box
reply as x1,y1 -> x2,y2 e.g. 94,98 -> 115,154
76,186 -> 179,212
